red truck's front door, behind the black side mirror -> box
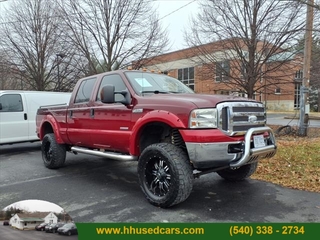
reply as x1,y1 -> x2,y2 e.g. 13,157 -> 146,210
91,74 -> 132,152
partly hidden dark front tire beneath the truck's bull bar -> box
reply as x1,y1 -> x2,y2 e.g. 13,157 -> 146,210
217,162 -> 258,181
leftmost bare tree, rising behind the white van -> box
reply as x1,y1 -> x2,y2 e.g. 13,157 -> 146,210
0,0 -> 79,91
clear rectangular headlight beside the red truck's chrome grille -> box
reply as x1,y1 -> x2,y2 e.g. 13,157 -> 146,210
189,108 -> 218,128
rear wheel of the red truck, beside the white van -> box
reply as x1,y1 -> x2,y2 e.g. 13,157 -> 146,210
41,133 -> 66,169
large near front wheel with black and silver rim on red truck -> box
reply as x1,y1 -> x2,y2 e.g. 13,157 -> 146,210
138,143 -> 193,208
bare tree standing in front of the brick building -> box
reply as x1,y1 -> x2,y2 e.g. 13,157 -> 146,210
185,0 -> 305,98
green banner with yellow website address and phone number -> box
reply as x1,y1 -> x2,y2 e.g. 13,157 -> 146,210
76,223 -> 320,240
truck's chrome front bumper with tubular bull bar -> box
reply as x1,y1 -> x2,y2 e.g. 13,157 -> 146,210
186,127 -> 277,169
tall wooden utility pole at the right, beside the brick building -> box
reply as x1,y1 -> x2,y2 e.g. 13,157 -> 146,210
298,0 -> 314,136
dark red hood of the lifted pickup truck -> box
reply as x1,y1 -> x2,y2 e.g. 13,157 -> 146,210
142,93 -> 254,108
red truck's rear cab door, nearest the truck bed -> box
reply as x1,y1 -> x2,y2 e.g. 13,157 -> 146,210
67,77 -> 96,147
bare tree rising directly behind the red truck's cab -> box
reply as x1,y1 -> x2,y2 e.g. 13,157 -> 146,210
60,0 -> 168,75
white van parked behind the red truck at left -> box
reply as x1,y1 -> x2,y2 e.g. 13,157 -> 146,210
0,90 -> 71,145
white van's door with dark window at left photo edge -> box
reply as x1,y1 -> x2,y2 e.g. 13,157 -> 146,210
0,93 -> 29,144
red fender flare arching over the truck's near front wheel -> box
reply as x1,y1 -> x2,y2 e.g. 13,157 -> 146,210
129,110 -> 187,156
